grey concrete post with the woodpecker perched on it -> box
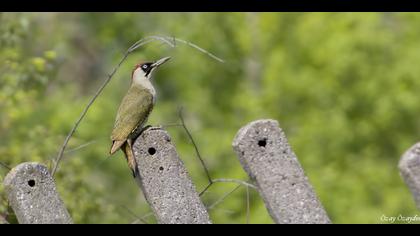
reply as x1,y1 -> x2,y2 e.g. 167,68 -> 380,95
133,129 -> 211,224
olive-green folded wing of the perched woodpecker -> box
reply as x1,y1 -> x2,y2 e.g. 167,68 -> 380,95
111,85 -> 153,141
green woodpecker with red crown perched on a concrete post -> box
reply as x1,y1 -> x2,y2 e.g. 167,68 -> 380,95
110,57 -> 170,177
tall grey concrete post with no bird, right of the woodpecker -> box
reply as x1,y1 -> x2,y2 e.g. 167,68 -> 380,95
233,120 -> 330,223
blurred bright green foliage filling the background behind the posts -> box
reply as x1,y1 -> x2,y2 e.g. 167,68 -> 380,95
0,13 -> 420,223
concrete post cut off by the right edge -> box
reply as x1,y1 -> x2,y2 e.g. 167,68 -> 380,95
398,143 -> 420,209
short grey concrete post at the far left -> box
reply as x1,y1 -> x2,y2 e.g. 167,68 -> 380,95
4,163 -> 72,224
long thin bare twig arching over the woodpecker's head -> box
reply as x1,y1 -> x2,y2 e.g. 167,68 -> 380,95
51,36 -> 223,177
